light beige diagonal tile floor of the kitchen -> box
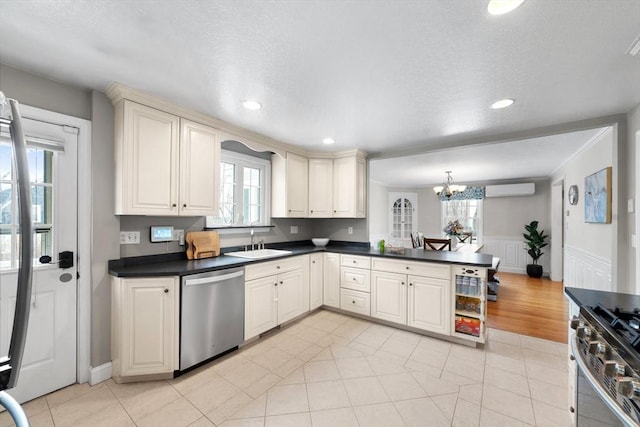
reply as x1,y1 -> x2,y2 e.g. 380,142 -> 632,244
0,310 -> 570,427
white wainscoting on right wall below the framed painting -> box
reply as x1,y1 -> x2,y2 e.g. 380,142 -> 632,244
564,245 -> 615,292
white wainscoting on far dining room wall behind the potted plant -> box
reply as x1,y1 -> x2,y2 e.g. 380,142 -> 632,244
482,236 -> 549,275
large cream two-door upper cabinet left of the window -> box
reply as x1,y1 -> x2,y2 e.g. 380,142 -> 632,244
115,99 -> 220,216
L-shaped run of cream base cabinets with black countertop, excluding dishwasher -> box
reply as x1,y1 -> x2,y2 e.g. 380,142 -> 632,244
109,241 -> 493,381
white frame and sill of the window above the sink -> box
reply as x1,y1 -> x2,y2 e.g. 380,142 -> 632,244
205,150 -> 271,231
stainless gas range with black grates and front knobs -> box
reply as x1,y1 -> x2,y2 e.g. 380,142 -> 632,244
571,304 -> 640,426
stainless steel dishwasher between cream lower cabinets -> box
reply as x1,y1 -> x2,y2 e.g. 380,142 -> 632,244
180,267 -> 244,371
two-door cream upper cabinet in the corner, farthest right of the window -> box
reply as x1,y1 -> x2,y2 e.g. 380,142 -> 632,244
309,154 -> 367,218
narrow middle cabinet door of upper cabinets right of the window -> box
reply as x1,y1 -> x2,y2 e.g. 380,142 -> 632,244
309,159 -> 333,218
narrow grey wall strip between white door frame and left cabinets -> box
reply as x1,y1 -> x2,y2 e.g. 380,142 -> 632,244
90,91 -> 120,367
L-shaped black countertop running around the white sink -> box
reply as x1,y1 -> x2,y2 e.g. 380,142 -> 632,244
109,241 -> 493,277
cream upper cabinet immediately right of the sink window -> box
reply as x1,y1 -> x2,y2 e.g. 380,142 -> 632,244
271,153 -> 309,218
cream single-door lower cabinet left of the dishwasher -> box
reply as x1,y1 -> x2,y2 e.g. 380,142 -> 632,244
111,277 -> 180,382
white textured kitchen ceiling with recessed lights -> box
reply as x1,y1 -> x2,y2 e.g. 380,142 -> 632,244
0,0 -> 640,186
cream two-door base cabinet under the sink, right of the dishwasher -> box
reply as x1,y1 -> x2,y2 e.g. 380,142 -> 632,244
244,255 -> 309,340
